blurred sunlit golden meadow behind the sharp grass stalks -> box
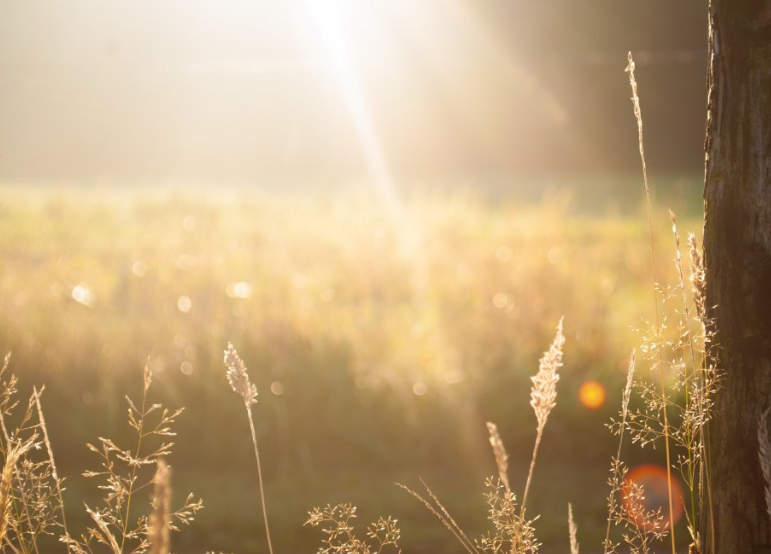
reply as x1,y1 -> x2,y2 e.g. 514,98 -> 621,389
0,183 -> 701,554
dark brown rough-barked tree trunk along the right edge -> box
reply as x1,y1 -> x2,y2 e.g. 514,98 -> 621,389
701,0 -> 771,554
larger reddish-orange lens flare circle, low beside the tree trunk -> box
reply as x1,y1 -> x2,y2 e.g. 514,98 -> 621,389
621,464 -> 684,531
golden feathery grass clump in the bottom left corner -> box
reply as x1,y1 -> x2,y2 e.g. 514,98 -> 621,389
0,355 -> 203,554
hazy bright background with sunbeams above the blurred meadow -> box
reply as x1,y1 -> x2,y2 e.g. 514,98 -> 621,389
0,0 -> 706,187
